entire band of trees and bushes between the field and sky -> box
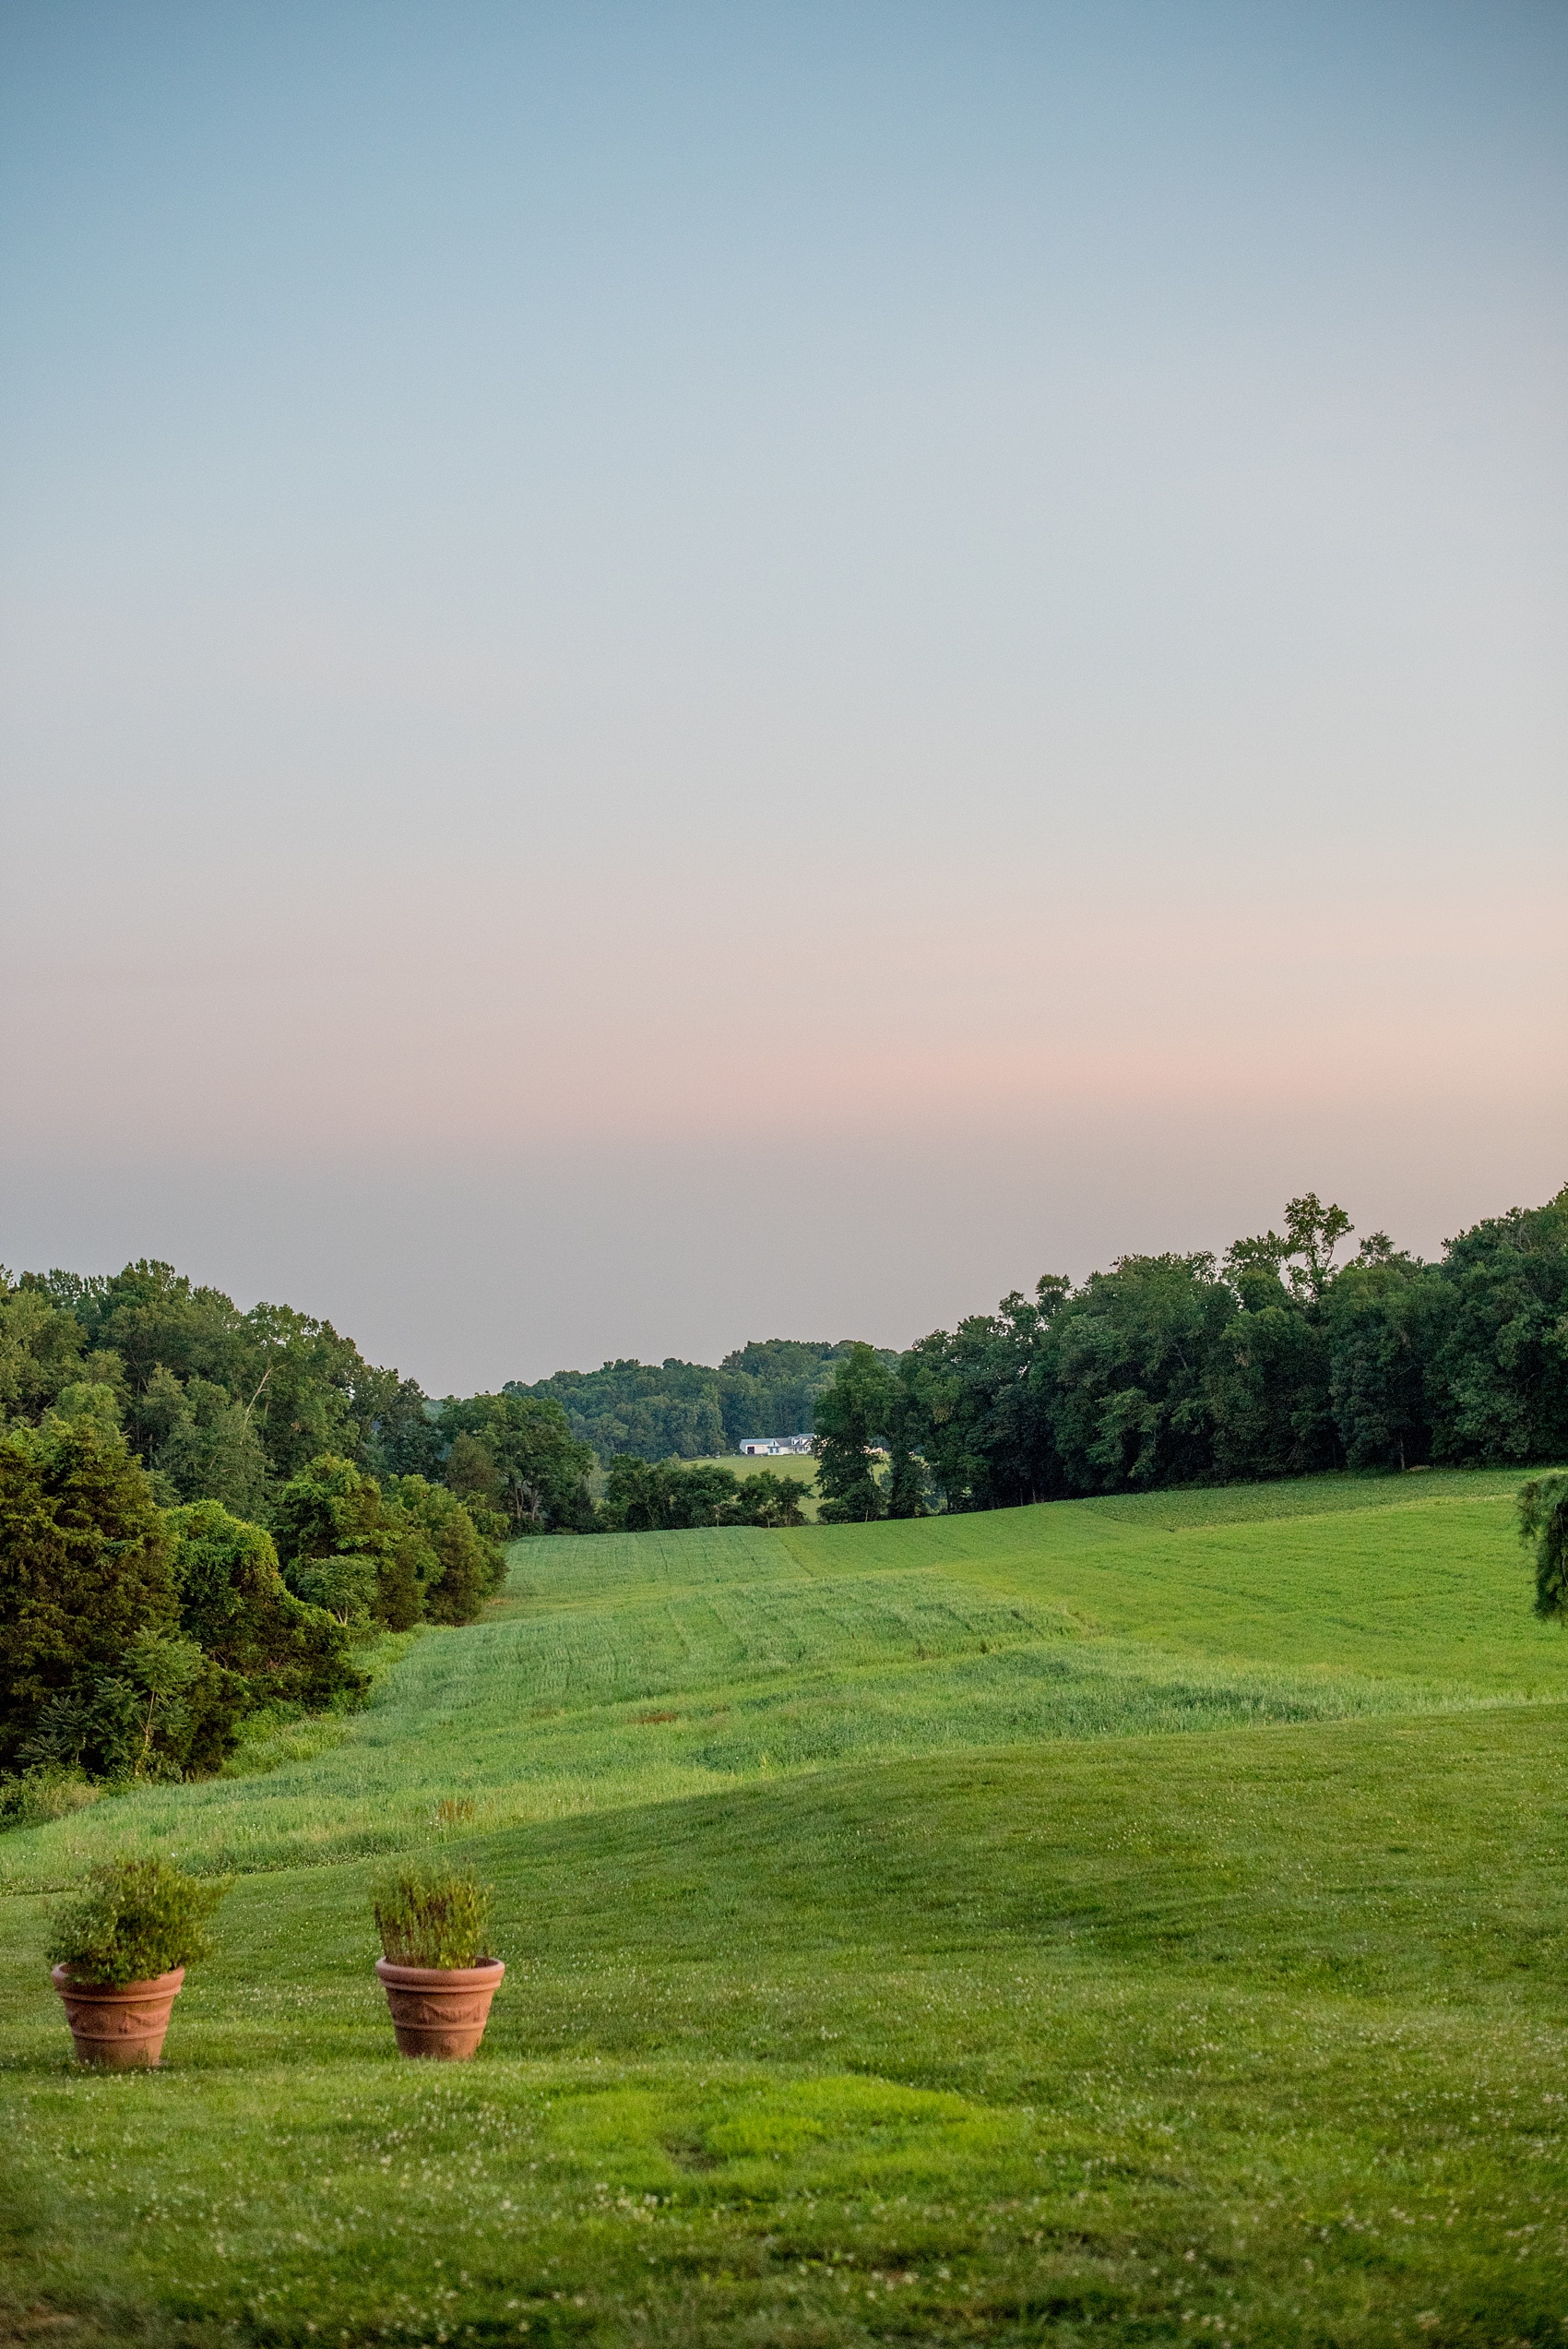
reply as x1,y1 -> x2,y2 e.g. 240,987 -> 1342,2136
0,1188 -> 1568,1808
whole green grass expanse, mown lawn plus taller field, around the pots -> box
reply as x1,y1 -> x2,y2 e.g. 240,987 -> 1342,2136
0,1475 -> 1568,2349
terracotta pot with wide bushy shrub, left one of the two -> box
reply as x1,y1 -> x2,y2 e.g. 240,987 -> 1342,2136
47,1860 -> 228,2067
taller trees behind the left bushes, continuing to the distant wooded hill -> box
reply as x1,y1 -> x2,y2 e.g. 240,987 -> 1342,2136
0,1259 -> 868,1536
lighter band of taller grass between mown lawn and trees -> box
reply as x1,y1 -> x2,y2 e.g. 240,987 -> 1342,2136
0,1475 -> 1568,1886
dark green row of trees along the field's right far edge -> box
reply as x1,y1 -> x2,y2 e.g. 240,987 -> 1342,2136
814,1186 -> 1568,1520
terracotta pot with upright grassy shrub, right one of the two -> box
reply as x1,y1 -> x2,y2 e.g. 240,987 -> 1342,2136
371,1867 -> 507,2062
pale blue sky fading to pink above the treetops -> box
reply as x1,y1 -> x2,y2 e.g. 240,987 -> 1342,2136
0,0 -> 1568,1393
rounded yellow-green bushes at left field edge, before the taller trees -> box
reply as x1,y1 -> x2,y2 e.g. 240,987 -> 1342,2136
0,1393 -> 505,1775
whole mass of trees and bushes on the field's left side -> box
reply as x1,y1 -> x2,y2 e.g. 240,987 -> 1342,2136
0,1261 -> 530,1820
